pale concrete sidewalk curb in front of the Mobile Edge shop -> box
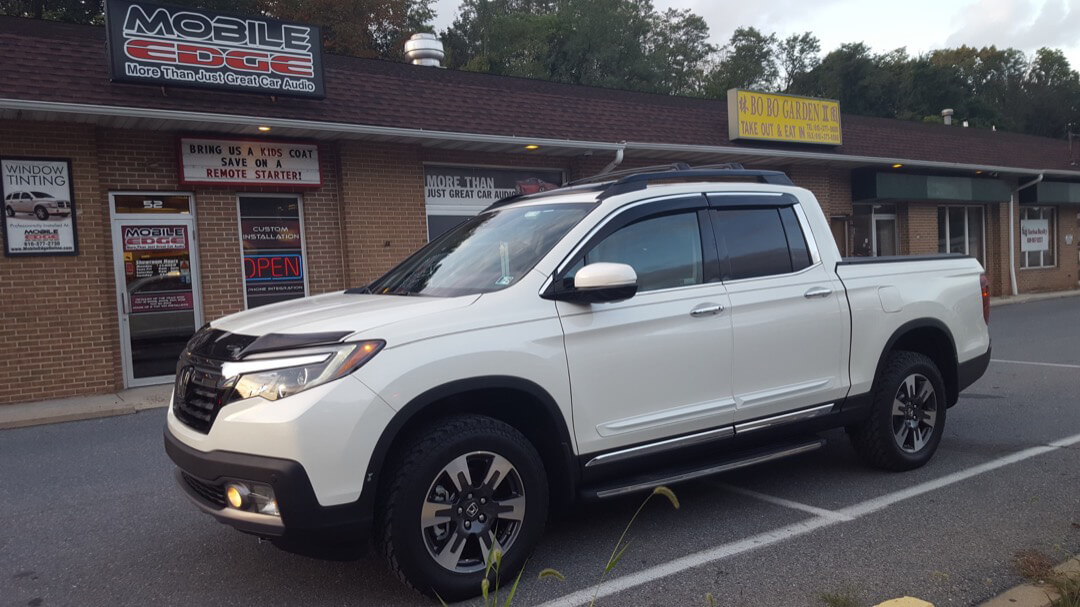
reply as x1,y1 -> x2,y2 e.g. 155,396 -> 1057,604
0,385 -> 173,430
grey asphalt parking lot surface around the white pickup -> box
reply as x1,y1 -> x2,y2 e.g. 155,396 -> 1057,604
0,298 -> 1080,607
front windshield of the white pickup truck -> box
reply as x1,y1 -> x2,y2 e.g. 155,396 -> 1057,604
365,203 -> 595,297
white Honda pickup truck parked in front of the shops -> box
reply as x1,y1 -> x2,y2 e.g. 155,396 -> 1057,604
165,165 -> 990,599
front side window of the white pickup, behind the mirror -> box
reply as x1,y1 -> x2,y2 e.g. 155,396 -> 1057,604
571,212 -> 704,293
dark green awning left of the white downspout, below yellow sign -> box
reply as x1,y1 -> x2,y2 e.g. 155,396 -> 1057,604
851,171 -> 1010,202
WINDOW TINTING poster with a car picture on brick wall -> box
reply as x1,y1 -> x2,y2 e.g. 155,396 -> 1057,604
0,158 -> 79,257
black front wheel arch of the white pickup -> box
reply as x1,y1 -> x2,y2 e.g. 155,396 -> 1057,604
364,376 -> 578,518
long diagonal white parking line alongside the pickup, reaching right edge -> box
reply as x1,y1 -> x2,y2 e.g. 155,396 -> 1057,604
541,427 -> 1080,607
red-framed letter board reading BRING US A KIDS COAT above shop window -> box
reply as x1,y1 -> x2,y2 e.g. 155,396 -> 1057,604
179,137 -> 323,188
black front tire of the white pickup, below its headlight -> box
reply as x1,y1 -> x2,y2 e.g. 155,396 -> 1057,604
376,415 -> 548,602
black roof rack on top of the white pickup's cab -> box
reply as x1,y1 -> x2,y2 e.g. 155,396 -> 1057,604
485,162 -> 795,211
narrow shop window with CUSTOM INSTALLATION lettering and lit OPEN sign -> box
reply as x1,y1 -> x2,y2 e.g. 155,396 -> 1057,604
240,197 -> 308,308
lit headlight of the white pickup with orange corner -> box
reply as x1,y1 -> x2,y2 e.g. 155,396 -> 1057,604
221,340 -> 387,403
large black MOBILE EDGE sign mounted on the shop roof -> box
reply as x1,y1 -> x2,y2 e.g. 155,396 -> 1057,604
105,0 -> 326,98
